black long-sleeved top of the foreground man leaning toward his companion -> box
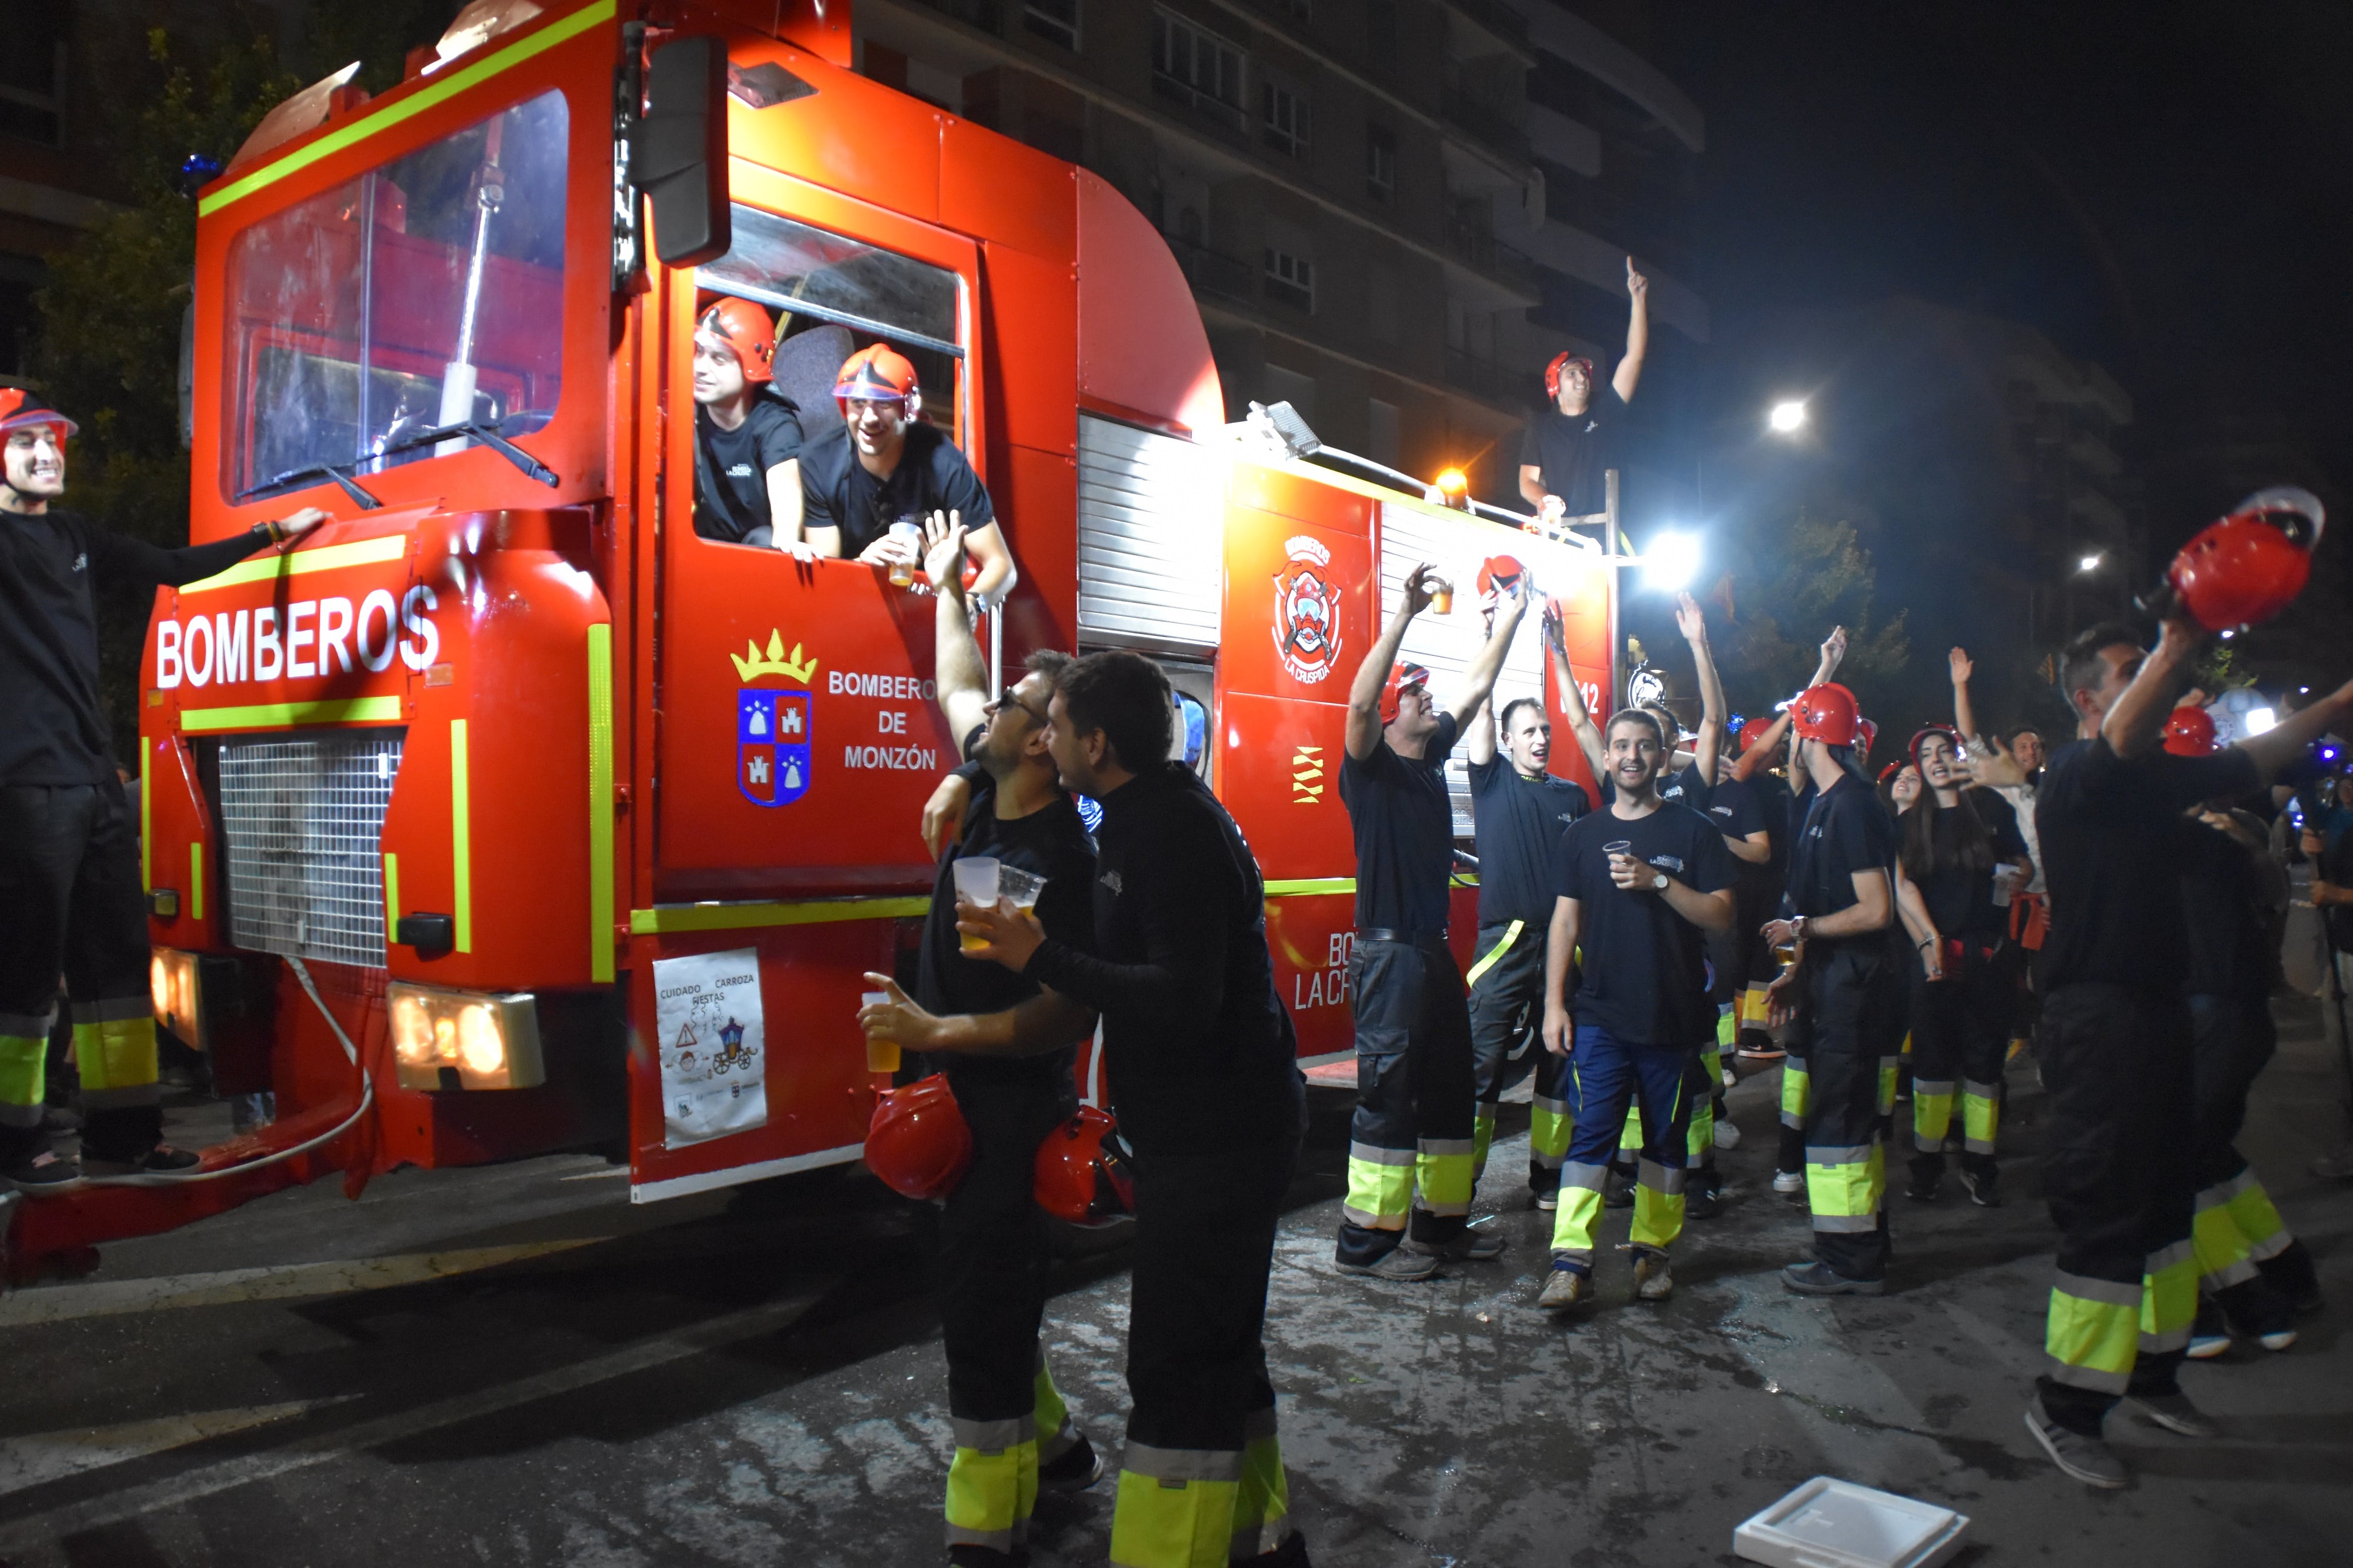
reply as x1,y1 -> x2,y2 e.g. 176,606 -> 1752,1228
1024,763 -> 1306,1158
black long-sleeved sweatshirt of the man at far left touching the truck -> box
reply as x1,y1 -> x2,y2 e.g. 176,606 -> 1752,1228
0,506 -> 271,784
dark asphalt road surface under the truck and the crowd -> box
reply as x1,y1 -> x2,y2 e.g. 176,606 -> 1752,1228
0,1000 -> 2353,1568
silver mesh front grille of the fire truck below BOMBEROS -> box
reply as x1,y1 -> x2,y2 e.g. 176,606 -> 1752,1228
219,730 -> 407,970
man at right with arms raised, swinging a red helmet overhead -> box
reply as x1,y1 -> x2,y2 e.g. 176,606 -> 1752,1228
2026,622 -> 2353,1488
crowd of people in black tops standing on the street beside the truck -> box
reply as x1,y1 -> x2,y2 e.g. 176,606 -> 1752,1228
861,485 -> 2353,1566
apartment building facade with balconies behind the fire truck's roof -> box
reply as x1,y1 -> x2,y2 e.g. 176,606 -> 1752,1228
856,0 -> 1708,499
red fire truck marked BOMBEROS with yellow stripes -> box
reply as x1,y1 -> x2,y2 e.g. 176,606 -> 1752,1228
14,0 -> 1614,1269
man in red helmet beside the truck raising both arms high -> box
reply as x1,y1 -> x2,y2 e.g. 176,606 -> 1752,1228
1334,565 -> 1534,1279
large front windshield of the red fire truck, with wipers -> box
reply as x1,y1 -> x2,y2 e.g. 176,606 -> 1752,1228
224,92 -> 569,499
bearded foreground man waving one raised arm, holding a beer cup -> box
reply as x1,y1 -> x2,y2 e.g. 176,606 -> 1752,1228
859,523 -> 1101,1563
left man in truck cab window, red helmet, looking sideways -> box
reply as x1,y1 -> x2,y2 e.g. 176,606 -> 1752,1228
694,296 -> 814,561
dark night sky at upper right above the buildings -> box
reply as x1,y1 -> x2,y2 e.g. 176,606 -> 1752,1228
1628,0 -> 2353,706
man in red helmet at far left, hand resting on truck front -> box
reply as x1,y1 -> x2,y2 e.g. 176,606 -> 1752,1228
0,386 -> 327,1194
